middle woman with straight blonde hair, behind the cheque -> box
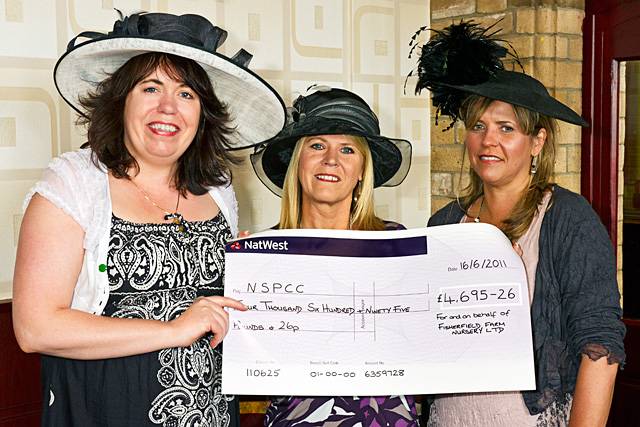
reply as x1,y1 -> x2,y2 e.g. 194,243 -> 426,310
251,87 -> 417,427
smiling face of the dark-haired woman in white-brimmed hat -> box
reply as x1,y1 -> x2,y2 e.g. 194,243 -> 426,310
124,68 -> 200,170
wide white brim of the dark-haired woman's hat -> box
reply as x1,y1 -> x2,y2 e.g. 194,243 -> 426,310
54,36 -> 286,150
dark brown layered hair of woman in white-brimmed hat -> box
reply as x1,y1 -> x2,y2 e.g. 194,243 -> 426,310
78,52 -> 240,196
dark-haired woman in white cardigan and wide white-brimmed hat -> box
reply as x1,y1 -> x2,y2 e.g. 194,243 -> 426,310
13,14 -> 285,427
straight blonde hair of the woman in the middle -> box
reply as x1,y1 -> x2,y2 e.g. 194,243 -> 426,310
278,135 -> 384,230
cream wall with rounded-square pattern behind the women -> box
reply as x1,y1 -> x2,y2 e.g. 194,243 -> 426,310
0,0 -> 430,299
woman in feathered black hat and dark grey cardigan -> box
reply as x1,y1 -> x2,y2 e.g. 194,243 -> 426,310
417,22 -> 625,427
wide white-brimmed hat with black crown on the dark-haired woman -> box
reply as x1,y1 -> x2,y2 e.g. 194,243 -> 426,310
53,13 -> 286,150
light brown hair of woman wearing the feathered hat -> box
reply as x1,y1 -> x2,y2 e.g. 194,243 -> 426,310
460,95 -> 558,241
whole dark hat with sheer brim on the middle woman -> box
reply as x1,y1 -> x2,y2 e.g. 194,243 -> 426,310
251,86 -> 411,196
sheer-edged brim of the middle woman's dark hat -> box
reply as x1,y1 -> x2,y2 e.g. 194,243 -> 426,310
250,120 -> 411,196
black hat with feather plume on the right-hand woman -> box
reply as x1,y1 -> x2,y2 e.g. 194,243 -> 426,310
411,21 -> 589,130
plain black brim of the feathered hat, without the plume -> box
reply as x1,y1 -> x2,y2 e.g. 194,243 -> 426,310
442,71 -> 589,127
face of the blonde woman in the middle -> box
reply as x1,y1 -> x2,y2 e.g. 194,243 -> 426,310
298,135 -> 364,209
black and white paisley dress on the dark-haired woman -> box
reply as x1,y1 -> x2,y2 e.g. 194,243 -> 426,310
43,213 -> 239,427
